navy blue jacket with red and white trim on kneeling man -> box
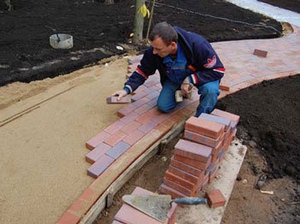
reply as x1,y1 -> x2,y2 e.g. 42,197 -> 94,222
124,26 -> 225,93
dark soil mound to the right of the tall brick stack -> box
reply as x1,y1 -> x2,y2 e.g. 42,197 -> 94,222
218,75 -> 300,181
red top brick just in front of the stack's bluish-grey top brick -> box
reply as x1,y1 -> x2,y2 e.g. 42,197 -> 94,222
185,117 -> 224,138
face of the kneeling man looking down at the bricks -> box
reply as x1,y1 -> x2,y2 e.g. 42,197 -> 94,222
151,37 -> 177,58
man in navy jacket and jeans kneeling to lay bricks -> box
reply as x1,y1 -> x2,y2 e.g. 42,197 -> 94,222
114,22 -> 225,117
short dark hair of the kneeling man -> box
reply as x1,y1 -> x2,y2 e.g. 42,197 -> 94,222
149,22 -> 178,45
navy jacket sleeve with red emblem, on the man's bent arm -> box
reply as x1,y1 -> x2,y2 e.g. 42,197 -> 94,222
189,41 -> 225,85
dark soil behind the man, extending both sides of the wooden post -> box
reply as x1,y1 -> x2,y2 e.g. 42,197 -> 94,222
0,0 -> 282,86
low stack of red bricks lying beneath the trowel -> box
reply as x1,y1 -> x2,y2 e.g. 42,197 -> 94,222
112,187 -> 177,224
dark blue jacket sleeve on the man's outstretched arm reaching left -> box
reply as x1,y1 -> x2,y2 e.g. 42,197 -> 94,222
123,47 -> 157,94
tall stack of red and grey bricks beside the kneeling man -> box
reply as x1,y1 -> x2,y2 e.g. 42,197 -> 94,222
159,109 -> 239,198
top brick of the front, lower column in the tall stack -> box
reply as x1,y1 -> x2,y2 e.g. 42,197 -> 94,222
174,139 -> 212,162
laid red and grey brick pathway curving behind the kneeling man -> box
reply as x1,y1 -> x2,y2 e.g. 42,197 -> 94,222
58,26 -> 300,224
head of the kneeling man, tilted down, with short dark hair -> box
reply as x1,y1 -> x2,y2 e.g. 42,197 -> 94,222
149,22 -> 178,58
